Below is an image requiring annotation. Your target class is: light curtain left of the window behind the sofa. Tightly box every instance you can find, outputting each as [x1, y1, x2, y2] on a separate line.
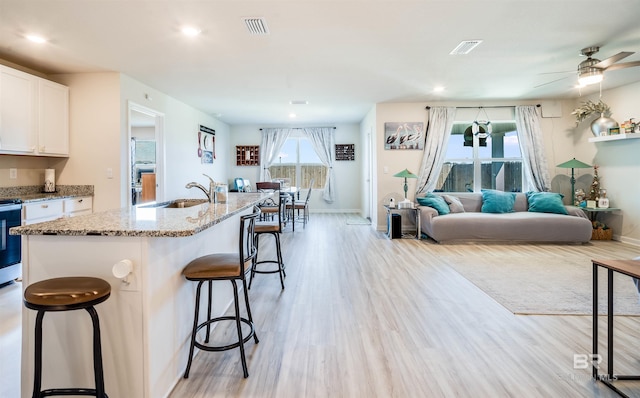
[416, 106, 456, 194]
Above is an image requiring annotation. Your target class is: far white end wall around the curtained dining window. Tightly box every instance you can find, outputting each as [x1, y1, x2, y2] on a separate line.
[228, 124, 363, 213]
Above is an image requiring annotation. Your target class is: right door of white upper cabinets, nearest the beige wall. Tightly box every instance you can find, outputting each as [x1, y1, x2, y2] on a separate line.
[38, 79, 69, 156]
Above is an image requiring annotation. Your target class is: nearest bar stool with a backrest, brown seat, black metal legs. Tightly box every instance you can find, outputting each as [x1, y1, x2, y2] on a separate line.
[182, 207, 260, 379]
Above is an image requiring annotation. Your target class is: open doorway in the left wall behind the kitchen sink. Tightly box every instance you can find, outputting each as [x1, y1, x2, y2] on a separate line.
[127, 102, 164, 206]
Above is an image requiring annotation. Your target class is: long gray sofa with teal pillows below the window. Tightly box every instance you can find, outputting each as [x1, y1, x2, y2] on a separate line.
[418, 192, 593, 243]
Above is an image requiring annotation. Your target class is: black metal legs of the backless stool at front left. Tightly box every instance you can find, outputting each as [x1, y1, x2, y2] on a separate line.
[33, 306, 108, 398]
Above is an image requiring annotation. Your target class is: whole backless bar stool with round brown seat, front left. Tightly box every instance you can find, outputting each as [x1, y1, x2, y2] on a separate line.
[24, 276, 111, 398]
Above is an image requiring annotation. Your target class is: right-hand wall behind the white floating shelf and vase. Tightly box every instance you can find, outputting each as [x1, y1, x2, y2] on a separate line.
[574, 83, 640, 245]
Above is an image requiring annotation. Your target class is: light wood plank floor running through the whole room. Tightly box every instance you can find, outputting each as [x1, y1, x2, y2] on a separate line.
[0, 214, 640, 398]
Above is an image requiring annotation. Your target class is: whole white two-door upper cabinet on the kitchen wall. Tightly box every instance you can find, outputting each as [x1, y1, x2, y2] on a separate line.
[0, 65, 69, 156]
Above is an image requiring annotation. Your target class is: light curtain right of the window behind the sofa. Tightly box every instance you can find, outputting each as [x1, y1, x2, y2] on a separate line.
[516, 105, 551, 192]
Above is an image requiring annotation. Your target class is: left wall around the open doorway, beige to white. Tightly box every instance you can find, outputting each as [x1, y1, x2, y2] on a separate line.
[55, 73, 229, 211]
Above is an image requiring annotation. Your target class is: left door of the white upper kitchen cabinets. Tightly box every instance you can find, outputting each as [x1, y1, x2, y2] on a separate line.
[0, 65, 38, 154]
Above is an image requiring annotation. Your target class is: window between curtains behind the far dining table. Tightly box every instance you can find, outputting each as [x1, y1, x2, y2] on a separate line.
[269, 137, 327, 189]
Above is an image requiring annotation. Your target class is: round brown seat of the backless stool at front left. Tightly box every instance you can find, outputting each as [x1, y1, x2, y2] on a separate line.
[24, 276, 111, 311]
